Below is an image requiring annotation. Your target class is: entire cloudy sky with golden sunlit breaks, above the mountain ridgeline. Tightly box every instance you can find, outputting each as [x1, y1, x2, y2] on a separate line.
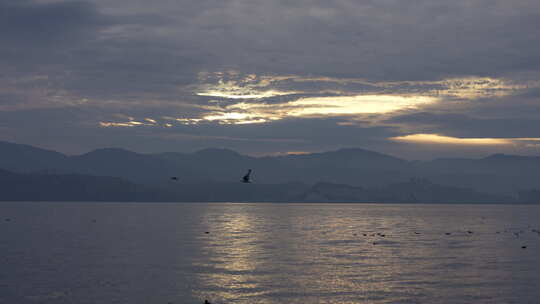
[0, 0, 540, 159]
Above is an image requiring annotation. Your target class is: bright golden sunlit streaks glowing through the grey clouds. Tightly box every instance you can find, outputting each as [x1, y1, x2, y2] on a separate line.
[96, 71, 540, 128]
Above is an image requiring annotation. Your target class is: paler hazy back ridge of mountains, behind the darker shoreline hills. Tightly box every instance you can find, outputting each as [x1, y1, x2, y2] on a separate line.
[0, 142, 540, 197]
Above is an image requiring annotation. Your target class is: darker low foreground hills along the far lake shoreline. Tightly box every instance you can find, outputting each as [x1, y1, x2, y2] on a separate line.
[0, 170, 516, 203]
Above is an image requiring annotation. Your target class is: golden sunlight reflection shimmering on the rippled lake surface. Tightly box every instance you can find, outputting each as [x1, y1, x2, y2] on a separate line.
[187, 203, 533, 304]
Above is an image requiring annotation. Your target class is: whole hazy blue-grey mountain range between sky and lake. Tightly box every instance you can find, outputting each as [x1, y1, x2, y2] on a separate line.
[0, 142, 540, 202]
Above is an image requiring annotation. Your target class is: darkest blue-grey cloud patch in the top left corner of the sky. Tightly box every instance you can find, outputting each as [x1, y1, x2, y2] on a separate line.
[0, 0, 110, 72]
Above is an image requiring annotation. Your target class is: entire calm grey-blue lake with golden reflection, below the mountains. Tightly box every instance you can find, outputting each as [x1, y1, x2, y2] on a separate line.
[0, 203, 540, 304]
